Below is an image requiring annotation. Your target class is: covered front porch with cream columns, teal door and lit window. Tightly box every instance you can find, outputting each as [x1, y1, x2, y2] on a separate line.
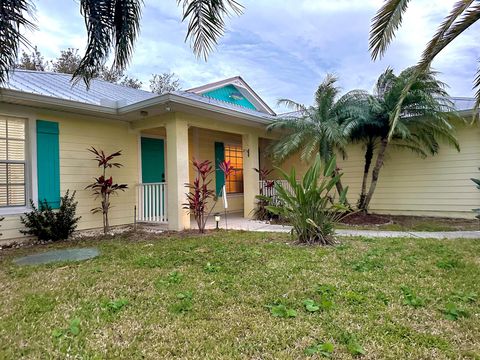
[133, 113, 274, 230]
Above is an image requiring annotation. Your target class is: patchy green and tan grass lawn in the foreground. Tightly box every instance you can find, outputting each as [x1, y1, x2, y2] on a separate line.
[0, 231, 480, 359]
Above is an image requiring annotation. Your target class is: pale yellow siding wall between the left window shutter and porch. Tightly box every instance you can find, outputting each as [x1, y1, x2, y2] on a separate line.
[0, 112, 138, 239]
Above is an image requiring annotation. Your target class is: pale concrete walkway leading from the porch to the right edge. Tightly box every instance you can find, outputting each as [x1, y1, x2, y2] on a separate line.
[202, 214, 480, 239]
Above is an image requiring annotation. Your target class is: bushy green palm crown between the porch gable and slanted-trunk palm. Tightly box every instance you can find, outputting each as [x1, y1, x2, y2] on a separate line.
[267, 74, 364, 205]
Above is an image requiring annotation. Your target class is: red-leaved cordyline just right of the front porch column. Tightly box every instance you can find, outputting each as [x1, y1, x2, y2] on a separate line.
[183, 160, 235, 234]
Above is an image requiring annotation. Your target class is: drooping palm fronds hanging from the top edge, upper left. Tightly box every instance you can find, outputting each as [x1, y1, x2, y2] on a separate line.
[0, 0, 243, 86]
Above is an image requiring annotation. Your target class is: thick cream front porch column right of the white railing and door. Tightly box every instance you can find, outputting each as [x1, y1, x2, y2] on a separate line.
[166, 118, 190, 231]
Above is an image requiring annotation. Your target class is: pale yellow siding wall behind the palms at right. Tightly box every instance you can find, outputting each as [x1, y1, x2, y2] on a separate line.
[261, 125, 480, 218]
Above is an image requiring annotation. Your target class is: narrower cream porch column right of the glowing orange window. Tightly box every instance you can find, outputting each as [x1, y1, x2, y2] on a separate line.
[242, 134, 259, 218]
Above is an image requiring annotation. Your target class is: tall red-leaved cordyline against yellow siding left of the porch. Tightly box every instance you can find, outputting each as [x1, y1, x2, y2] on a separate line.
[85, 146, 128, 234]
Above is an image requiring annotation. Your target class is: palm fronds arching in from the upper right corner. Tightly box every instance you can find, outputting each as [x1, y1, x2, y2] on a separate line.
[370, 0, 480, 137]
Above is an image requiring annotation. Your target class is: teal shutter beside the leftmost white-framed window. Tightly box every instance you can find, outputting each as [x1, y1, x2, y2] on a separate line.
[37, 120, 60, 209]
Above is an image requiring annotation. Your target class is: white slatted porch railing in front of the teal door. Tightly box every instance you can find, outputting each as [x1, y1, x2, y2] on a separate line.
[137, 183, 168, 223]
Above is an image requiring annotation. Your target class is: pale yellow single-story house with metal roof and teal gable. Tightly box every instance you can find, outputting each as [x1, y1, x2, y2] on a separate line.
[0, 70, 480, 239]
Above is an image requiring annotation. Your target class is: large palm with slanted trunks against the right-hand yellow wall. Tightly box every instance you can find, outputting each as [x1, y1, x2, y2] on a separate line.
[346, 67, 460, 212]
